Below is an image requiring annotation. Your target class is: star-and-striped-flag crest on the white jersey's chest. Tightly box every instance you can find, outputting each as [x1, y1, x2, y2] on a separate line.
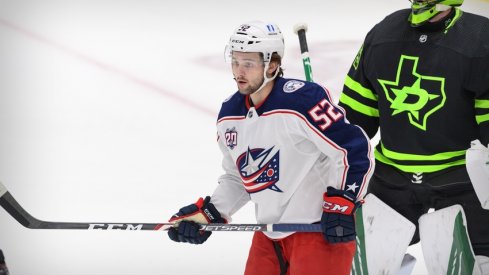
[236, 146, 282, 193]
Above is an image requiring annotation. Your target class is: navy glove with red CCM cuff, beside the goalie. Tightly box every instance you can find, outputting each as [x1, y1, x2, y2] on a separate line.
[321, 186, 362, 243]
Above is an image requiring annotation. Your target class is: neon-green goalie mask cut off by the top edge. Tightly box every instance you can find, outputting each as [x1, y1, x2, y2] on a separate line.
[409, 0, 464, 27]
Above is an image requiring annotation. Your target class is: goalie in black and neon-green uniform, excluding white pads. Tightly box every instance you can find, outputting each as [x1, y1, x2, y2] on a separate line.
[340, 0, 489, 274]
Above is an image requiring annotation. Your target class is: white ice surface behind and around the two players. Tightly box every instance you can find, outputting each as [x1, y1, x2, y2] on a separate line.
[0, 0, 489, 275]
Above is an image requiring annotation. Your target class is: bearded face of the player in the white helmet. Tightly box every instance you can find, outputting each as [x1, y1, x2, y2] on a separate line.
[231, 52, 265, 95]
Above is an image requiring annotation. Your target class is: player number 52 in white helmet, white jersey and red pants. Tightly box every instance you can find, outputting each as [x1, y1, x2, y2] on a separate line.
[168, 21, 373, 275]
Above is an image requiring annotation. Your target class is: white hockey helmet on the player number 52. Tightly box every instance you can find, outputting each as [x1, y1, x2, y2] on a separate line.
[225, 21, 284, 62]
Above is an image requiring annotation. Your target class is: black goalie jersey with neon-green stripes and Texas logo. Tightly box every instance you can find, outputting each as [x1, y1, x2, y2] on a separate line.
[340, 9, 489, 173]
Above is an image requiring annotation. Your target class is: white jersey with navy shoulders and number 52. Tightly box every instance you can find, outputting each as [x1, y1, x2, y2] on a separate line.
[211, 78, 374, 239]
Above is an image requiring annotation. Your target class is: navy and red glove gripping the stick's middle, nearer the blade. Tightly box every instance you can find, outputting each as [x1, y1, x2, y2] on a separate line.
[168, 196, 226, 244]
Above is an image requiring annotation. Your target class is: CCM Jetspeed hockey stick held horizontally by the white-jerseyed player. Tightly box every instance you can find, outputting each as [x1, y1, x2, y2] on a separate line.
[0, 182, 321, 232]
